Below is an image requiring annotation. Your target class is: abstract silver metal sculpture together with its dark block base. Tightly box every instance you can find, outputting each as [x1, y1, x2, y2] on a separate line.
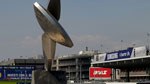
[32, 0, 73, 84]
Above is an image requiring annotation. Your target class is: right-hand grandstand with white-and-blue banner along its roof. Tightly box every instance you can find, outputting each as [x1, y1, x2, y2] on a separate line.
[91, 46, 150, 82]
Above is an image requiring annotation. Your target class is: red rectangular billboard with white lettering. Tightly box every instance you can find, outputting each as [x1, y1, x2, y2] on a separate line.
[89, 67, 111, 80]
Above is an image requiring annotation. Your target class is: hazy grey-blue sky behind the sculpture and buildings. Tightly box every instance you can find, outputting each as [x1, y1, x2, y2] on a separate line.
[0, 0, 150, 60]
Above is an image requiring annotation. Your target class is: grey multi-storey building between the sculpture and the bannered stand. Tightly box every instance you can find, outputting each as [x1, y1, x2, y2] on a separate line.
[52, 51, 97, 82]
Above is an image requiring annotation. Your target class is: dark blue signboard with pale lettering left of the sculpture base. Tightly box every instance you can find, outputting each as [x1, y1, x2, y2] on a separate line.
[0, 66, 44, 81]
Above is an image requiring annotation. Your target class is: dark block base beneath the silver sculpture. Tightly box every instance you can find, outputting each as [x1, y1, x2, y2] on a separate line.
[32, 70, 67, 84]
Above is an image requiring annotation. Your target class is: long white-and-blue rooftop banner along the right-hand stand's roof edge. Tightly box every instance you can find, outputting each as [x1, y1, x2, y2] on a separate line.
[92, 46, 147, 63]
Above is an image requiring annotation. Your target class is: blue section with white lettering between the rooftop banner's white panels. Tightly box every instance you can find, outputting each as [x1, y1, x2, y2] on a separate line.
[105, 48, 133, 61]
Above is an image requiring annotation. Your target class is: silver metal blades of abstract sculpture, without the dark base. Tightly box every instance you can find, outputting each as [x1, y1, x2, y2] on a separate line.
[34, 0, 73, 70]
